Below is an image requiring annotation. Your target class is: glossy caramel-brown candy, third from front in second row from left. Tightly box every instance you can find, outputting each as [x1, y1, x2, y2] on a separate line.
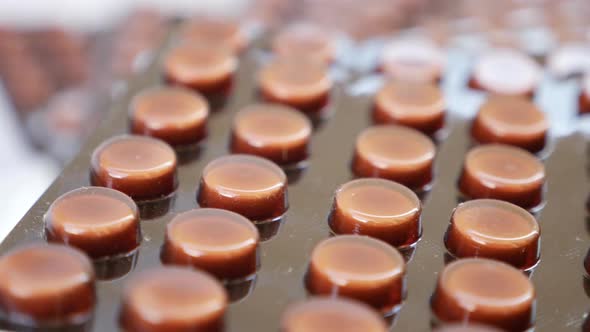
[197, 154, 288, 221]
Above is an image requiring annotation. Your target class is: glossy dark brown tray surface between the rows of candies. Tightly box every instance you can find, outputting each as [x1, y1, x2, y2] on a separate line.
[0, 24, 590, 332]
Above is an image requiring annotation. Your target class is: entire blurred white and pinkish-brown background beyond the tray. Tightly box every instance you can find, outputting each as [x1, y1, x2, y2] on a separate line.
[0, 0, 590, 239]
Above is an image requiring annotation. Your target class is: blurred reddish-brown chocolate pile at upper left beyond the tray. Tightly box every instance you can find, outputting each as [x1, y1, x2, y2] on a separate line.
[0, 10, 168, 162]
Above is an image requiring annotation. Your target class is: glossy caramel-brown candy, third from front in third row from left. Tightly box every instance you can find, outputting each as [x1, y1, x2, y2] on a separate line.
[329, 179, 422, 247]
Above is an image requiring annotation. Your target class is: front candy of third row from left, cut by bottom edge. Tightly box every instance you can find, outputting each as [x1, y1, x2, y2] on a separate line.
[280, 297, 388, 332]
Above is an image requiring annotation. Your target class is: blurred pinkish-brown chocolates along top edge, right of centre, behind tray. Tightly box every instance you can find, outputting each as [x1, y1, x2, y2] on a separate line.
[251, 0, 590, 53]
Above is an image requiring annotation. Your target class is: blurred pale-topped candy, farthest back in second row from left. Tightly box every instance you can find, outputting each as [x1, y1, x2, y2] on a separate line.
[272, 22, 336, 63]
